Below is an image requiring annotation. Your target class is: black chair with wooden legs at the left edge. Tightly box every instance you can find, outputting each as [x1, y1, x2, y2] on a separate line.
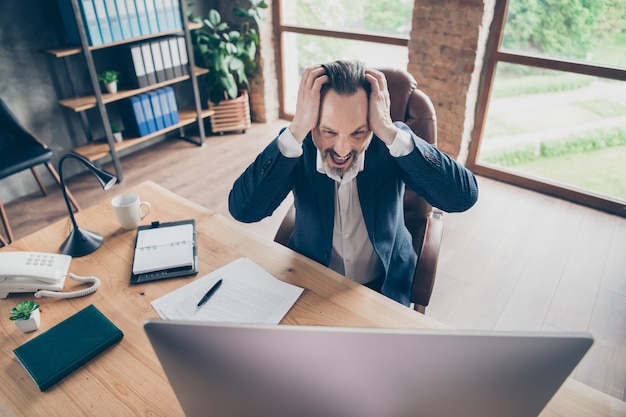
[0, 99, 80, 245]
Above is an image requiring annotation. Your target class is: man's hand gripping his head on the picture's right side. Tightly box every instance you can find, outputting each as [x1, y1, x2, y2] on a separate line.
[365, 68, 398, 146]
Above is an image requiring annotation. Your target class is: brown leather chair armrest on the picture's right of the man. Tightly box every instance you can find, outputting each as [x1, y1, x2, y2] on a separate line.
[411, 211, 443, 313]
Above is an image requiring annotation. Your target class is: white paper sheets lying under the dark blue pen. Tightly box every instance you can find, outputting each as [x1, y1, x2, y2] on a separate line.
[151, 258, 303, 324]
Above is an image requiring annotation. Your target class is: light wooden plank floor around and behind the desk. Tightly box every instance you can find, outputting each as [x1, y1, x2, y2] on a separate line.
[0, 121, 626, 400]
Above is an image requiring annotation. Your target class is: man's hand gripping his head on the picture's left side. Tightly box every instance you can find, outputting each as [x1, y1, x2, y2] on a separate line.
[289, 65, 328, 143]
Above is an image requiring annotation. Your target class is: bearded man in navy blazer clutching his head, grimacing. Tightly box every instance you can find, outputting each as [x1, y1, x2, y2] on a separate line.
[229, 61, 478, 305]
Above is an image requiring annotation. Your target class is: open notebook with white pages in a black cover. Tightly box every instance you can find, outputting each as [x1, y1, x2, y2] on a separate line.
[131, 219, 198, 284]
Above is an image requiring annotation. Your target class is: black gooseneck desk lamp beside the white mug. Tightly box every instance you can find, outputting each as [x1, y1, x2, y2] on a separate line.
[59, 153, 117, 257]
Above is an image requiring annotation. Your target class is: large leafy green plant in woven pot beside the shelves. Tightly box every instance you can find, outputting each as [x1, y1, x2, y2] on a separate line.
[189, 0, 267, 133]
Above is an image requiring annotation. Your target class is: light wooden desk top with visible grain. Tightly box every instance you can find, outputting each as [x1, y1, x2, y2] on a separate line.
[0, 182, 626, 417]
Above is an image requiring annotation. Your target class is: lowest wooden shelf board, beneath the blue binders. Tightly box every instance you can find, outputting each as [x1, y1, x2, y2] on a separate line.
[72, 109, 215, 162]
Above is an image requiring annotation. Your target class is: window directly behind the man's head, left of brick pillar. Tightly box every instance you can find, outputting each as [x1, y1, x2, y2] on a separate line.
[277, 0, 413, 117]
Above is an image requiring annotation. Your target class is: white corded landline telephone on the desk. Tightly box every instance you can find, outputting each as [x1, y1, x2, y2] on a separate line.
[0, 251, 100, 298]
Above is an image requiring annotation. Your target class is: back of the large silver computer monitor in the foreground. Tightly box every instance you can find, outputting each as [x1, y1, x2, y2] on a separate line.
[145, 320, 593, 417]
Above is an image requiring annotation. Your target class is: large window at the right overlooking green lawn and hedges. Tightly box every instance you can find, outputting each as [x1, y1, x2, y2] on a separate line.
[468, 0, 626, 215]
